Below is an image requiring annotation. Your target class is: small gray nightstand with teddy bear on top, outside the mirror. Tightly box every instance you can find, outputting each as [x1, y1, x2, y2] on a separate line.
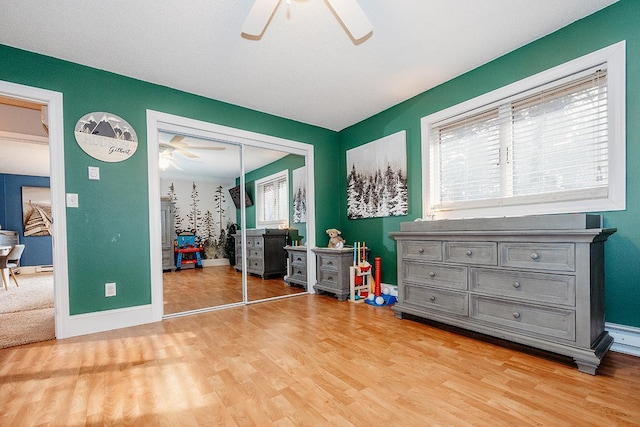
[312, 248, 353, 301]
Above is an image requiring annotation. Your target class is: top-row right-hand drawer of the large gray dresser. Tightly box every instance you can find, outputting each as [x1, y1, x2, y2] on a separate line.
[500, 243, 576, 271]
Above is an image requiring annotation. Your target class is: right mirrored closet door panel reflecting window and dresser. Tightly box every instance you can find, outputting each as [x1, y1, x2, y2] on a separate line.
[240, 146, 307, 301]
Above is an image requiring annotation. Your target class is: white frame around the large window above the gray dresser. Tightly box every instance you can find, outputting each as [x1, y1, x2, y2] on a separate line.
[421, 41, 626, 219]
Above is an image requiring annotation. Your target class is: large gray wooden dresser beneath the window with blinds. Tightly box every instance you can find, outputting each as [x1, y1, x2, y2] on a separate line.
[391, 214, 616, 374]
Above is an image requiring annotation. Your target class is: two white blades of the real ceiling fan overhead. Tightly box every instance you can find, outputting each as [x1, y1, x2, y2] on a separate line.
[242, 0, 373, 41]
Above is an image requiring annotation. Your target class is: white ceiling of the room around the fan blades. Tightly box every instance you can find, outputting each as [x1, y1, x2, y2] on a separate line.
[0, 0, 616, 130]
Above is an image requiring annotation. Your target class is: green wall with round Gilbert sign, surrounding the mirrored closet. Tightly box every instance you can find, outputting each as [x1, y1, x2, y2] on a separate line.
[0, 45, 339, 315]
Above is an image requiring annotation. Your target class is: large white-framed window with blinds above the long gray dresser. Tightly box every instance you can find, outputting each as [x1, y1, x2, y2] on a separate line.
[422, 42, 625, 218]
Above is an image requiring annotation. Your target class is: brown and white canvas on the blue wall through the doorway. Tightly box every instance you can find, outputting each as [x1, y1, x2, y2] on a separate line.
[22, 187, 53, 237]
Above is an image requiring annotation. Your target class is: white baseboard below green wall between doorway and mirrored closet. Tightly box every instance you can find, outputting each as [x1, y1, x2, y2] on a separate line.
[67, 304, 153, 337]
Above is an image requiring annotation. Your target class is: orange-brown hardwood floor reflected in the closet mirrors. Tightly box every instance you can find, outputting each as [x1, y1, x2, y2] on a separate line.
[162, 266, 305, 314]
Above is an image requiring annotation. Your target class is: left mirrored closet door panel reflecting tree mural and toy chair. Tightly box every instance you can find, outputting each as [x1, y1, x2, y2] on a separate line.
[159, 132, 243, 315]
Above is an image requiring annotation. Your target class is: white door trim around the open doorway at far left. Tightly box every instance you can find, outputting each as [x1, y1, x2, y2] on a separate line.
[0, 81, 71, 338]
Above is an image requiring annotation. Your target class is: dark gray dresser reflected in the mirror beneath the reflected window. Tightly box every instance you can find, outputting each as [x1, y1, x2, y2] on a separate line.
[233, 228, 287, 279]
